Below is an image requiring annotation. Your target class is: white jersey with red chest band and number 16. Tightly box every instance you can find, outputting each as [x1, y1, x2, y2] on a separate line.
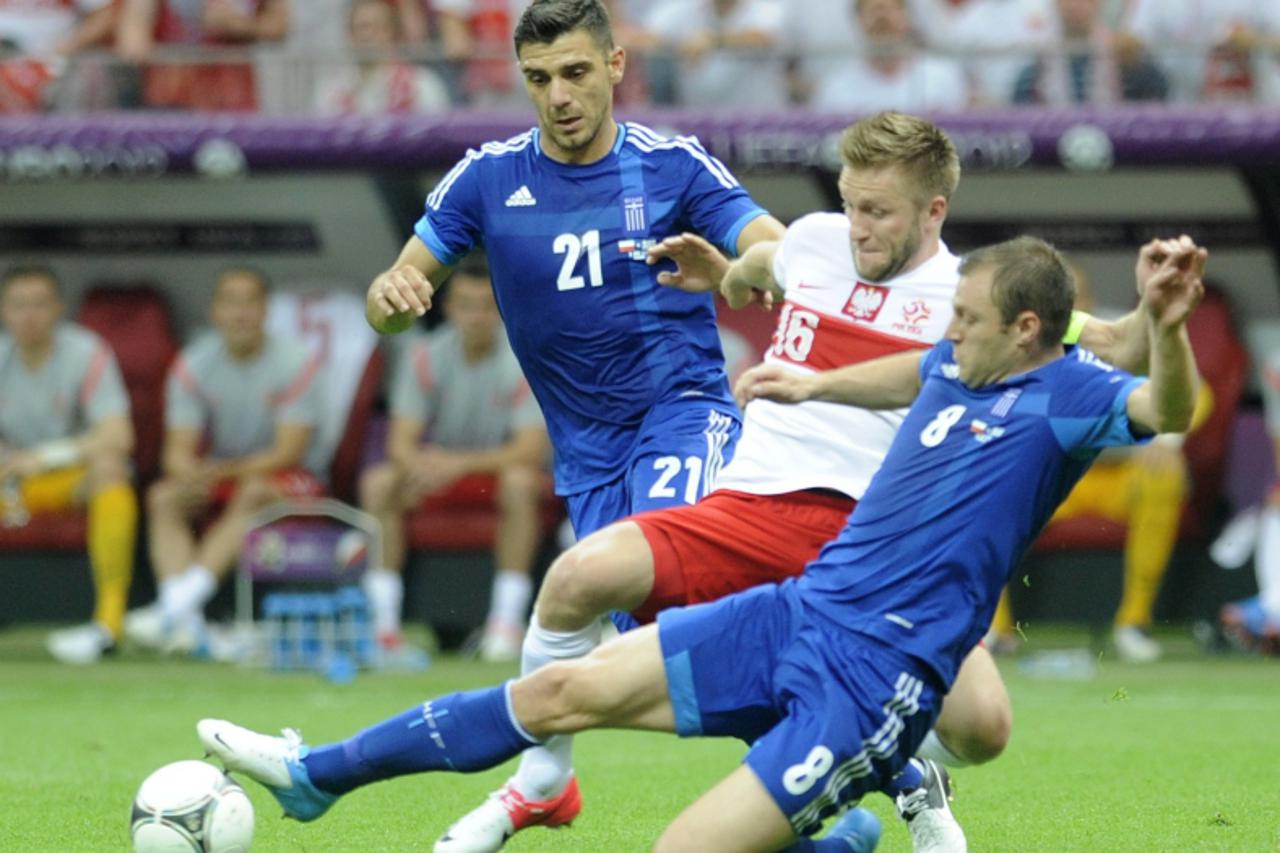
[716, 213, 960, 500]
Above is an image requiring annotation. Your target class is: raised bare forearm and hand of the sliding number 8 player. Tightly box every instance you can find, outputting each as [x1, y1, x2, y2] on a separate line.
[1126, 247, 1207, 433]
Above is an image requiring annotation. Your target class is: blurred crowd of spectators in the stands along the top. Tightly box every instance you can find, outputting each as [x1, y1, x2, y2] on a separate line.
[0, 0, 1280, 115]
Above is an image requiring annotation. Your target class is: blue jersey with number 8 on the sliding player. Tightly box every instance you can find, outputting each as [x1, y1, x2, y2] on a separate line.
[799, 341, 1143, 685]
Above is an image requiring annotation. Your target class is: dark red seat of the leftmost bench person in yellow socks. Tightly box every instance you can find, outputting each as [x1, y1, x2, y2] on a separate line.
[0, 283, 178, 552]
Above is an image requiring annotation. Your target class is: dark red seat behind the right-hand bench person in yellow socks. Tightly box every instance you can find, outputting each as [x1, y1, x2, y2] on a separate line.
[1034, 287, 1249, 552]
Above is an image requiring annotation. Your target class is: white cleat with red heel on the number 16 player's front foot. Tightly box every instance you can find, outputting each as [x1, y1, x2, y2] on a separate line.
[431, 777, 582, 853]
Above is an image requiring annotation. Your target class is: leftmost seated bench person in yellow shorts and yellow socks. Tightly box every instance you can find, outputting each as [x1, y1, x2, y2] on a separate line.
[0, 265, 138, 663]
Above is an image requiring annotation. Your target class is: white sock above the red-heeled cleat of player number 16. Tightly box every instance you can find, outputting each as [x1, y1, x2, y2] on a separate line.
[512, 616, 600, 799]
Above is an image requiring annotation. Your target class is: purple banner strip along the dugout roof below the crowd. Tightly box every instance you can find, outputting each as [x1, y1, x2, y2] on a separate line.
[0, 105, 1280, 181]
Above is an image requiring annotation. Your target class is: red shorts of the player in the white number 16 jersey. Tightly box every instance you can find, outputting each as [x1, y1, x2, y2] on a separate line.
[631, 489, 856, 622]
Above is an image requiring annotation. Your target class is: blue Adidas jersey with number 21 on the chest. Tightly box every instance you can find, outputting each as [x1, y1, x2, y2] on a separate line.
[415, 123, 764, 494]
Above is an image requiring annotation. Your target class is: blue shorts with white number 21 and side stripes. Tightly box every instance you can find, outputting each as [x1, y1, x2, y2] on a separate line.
[564, 397, 742, 631]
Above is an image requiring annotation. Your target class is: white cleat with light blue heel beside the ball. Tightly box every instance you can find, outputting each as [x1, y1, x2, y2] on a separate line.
[196, 720, 338, 821]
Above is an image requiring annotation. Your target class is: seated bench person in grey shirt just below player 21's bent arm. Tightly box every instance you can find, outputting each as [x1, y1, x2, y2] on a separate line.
[360, 259, 550, 661]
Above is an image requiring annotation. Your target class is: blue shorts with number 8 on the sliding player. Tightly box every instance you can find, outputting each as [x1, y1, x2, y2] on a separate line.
[658, 581, 942, 835]
